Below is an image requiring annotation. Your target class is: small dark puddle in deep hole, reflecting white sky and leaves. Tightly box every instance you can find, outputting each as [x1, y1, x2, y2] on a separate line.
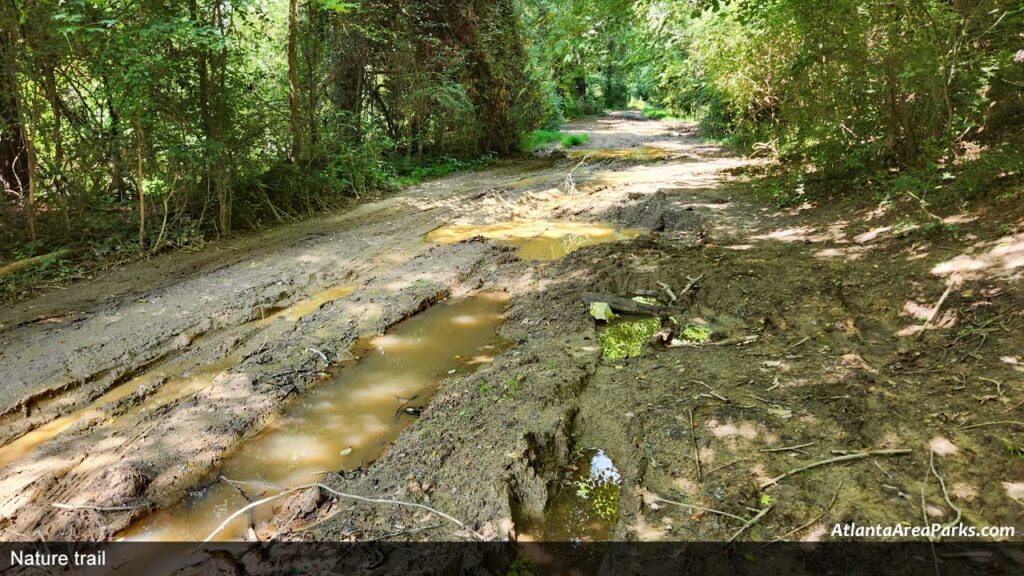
[516, 448, 623, 542]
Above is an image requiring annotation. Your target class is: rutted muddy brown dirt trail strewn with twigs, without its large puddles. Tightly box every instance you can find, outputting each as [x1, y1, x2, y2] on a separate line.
[0, 114, 1024, 540]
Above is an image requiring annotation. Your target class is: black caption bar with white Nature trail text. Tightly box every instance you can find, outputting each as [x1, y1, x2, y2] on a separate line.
[0, 542, 1024, 576]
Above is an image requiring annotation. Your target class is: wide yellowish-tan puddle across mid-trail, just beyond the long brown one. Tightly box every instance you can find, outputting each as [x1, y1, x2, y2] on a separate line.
[427, 220, 642, 260]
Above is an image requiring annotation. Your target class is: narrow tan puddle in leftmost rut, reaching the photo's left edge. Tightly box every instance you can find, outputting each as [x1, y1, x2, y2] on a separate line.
[0, 357, 239, 468]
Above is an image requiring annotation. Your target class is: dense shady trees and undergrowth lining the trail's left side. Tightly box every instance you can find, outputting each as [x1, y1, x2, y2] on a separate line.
[0, 0, 551, 289]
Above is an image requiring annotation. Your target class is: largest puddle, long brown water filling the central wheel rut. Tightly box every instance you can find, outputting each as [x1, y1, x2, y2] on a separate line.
[122, 293, 508, 542]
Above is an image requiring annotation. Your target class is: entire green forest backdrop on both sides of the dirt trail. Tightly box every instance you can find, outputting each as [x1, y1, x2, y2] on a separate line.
[0, 0, 1024, 290]
